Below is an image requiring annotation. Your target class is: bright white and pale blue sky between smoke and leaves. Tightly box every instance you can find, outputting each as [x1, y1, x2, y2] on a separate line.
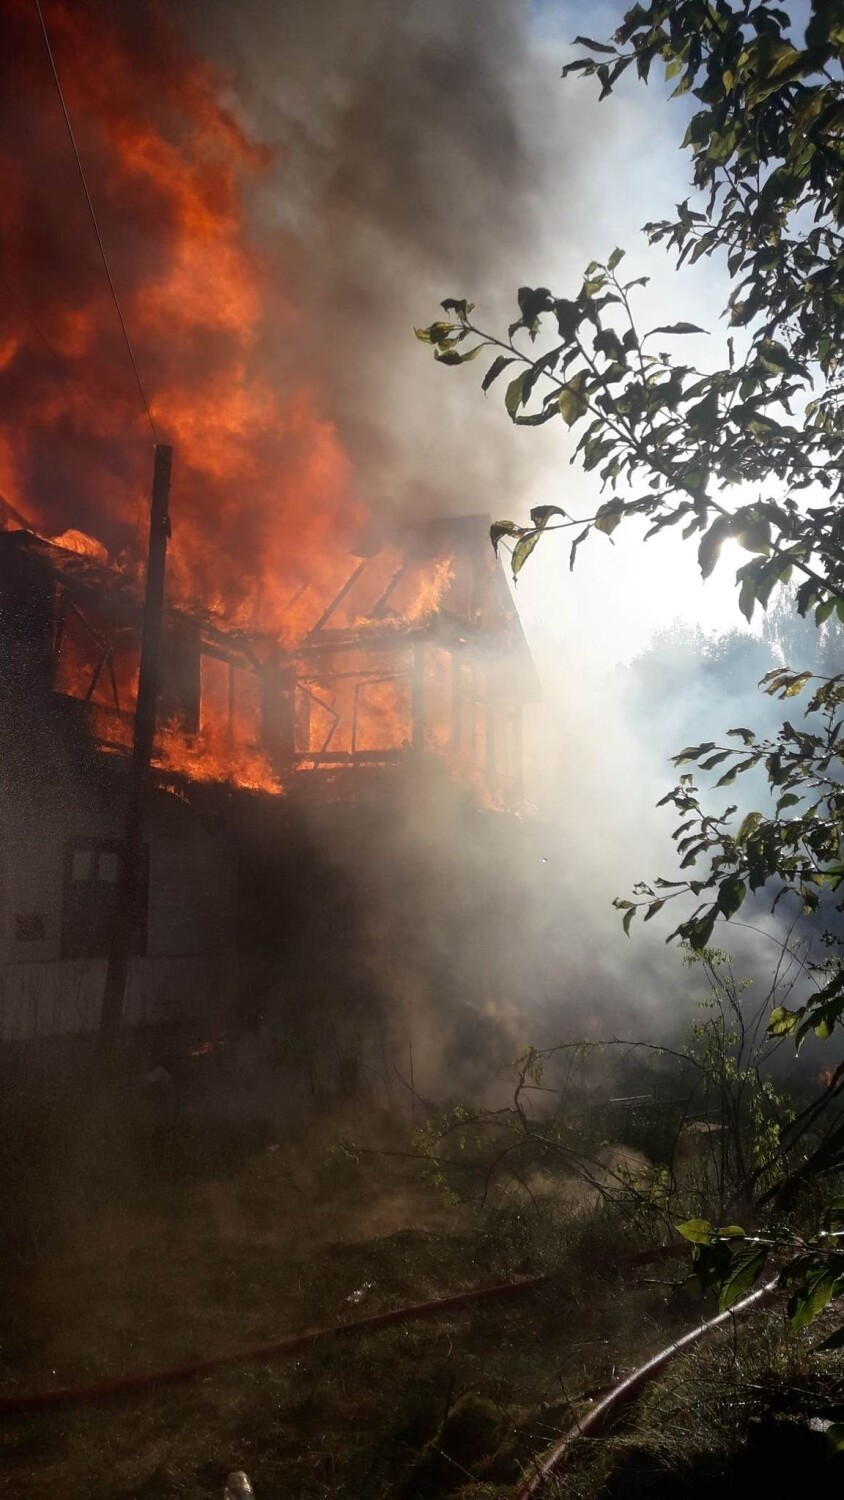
[511, 0, 758, 671]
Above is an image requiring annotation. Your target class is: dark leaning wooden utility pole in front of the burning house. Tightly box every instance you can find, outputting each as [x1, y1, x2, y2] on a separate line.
[99, 443, 172, 1053]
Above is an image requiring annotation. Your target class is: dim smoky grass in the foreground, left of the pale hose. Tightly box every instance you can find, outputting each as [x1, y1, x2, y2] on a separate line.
[0, 1056, 694, 1500]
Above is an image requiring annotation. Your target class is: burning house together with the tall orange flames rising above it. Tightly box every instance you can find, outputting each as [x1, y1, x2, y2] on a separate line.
[0, 0, 537, 1086]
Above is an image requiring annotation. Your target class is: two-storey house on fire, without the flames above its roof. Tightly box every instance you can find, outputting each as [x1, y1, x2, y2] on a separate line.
[0, 518, 537, 1068]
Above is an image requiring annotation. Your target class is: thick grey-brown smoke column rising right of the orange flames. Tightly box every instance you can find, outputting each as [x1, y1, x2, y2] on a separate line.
[183, 0, 600, 518]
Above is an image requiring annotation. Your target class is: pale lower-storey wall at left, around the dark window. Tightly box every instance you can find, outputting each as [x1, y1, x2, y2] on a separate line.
[0, 764, 241, 1041]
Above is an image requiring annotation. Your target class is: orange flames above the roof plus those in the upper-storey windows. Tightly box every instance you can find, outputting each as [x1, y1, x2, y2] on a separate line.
[0, 0, 515, 810]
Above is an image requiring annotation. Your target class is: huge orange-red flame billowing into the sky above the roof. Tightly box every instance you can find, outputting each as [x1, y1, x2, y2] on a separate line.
[0, 0, 364, 639]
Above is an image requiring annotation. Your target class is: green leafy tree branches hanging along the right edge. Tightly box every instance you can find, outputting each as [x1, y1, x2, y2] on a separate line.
[417, 0, 844, 1338]
